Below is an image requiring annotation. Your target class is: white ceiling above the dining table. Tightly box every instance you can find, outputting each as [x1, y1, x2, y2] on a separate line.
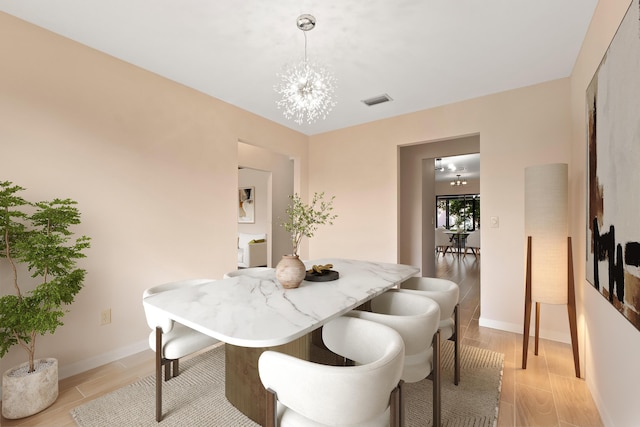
[0, 0, 597, 135]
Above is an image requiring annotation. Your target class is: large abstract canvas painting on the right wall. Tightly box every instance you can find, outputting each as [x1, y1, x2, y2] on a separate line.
[586, 0, 640, 330]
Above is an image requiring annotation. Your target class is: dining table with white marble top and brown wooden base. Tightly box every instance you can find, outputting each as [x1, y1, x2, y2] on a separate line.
[143, 258, 420, 425]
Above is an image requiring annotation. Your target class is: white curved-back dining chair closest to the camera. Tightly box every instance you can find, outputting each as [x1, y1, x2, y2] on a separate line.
[258, 317, 404, 427]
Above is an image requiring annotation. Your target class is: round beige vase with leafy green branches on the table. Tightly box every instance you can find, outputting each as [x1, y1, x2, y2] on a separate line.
[276, 192, 338, 289]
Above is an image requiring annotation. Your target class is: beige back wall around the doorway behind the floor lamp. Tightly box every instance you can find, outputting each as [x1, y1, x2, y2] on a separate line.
[309, 79, 571, 341]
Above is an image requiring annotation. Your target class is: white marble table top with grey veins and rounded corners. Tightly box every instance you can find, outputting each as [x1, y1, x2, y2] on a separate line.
[143, 259, 420, 347]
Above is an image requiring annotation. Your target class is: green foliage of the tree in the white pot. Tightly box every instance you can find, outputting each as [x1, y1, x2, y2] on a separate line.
[0, 181, 90, 372]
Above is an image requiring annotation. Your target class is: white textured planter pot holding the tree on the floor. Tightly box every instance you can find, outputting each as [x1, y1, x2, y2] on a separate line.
[2, 359, 58, 419]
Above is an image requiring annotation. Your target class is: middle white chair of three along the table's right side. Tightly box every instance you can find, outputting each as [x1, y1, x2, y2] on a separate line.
[348, 289, 442, 426]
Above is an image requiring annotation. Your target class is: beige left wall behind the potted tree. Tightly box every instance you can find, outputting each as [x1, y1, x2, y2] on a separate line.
[0, 13, 307, 376]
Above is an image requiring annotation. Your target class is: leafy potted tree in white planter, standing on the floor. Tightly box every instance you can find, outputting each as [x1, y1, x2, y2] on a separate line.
[0, 181, 90, 419]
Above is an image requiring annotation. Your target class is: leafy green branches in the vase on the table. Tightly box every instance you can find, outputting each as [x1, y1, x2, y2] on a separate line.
[281, 192, 338, 255]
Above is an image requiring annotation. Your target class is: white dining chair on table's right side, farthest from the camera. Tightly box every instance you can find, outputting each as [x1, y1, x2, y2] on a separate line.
[399, 277, 460, 385]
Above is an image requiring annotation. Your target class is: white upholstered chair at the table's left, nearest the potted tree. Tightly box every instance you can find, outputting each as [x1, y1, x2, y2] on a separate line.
[142, 279, 219, 422]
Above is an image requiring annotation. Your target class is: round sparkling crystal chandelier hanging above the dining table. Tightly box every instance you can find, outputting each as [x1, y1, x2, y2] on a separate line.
[274, 14, 336, 125]
